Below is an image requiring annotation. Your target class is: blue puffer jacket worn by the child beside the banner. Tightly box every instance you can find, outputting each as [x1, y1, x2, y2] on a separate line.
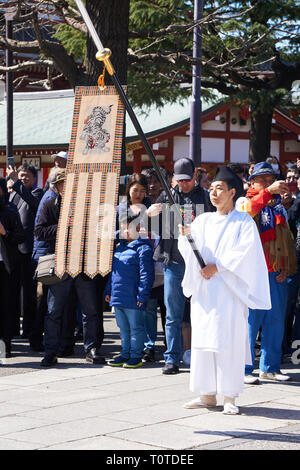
[105, 238, 154, 310]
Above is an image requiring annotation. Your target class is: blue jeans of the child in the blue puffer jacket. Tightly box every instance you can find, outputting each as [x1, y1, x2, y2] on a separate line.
[114, 306, 145, 359]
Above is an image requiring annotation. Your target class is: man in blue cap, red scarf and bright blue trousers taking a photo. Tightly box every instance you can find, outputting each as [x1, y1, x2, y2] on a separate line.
[237, 162, 297, 384]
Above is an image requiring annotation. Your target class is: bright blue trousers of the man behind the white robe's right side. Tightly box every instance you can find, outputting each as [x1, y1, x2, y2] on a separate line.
[246, 272, 288, 375]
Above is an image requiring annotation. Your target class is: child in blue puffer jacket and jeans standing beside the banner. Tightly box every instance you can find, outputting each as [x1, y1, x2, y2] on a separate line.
[105, 216, 154, 368]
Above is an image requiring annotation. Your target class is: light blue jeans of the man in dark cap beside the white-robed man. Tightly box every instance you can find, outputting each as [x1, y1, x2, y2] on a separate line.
[164, 263, 185, 365]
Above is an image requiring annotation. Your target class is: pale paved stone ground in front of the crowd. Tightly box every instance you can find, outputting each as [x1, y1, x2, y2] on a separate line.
[0, 313, 300, 452]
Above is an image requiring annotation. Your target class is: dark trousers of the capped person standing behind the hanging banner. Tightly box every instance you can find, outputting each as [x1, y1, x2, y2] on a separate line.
[45, 274, 104, 354]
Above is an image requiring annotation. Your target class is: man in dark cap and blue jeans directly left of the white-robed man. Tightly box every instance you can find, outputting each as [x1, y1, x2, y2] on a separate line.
[147, 158, 214, 375]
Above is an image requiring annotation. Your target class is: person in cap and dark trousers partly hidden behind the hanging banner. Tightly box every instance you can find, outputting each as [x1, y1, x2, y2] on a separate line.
[35, 168, 105, 367]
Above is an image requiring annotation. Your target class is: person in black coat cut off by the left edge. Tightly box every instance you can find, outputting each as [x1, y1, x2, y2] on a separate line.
[0, 178, 25, 357]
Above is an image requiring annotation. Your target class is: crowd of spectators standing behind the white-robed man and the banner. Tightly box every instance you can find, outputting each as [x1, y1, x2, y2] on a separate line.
[0, 152, 300, 406]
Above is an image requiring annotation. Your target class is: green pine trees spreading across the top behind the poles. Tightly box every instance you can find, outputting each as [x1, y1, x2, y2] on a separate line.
[0, 0, 300, 161]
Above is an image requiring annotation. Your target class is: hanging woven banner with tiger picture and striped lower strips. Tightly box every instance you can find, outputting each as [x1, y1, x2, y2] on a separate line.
[55, 86, 124, 278]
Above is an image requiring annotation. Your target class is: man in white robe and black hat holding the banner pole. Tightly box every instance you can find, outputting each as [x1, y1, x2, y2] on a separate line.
[178, 167, 271, 414]
